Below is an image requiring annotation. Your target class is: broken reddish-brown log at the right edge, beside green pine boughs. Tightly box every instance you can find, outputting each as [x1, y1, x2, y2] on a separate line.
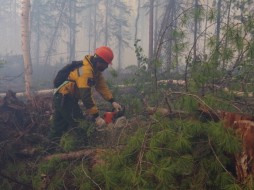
[198, 105, 254, 182]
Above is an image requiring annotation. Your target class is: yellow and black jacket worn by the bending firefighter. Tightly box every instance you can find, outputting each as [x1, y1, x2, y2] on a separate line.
[58, 55, 114, 115]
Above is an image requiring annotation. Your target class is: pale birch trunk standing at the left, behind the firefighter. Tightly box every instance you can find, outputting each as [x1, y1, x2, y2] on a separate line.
[21, 0, 32, 99]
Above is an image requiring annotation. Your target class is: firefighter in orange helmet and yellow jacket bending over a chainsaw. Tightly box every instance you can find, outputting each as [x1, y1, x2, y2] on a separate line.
[50, 46, 121, 138]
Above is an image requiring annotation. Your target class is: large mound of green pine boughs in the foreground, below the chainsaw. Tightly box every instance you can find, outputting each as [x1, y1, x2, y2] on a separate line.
[89, 118, 241, 189]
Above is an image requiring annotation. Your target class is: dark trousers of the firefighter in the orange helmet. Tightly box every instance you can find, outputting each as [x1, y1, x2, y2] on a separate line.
[49, 93, 84, 138]
